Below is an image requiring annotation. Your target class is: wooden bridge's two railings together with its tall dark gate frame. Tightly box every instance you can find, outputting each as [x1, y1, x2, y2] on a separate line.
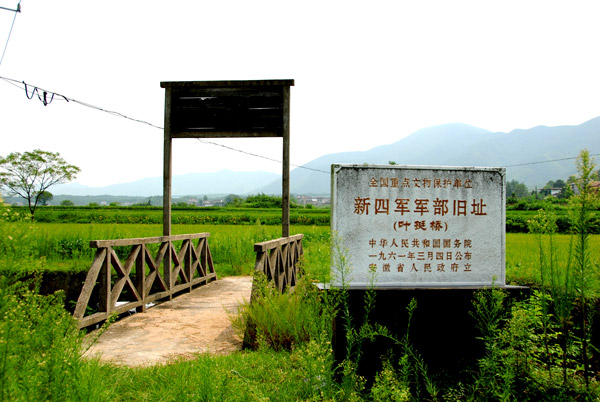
[74, 80, 303, 364]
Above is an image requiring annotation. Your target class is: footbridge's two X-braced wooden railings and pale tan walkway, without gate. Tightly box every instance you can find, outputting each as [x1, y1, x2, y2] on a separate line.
[74, 233, 304, 364]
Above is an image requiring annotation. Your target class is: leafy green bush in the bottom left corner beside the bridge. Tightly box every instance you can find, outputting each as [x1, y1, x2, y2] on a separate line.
[0, 276, 82, 401]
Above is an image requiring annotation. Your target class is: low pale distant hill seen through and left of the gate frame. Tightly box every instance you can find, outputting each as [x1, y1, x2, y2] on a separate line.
[50, 170, 281, 197]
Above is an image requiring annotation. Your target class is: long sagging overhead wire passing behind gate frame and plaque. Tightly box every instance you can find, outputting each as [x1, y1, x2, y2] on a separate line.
[0, 76, 600, 174]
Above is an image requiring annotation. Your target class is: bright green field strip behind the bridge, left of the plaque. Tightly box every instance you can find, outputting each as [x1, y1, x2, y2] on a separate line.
[0, 222, 329, 275]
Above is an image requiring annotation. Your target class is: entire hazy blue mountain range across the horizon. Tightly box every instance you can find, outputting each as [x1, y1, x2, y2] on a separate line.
[51, 117, 600, 196]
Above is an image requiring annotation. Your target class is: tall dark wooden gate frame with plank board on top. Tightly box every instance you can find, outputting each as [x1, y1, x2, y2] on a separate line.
[160, 80, 294, 237]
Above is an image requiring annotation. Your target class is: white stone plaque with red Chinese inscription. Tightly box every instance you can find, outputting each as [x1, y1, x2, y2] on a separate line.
[331, 165, 505, 287]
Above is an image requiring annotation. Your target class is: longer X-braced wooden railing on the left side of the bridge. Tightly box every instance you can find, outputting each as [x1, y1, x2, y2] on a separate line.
[73, 233, 217, 328]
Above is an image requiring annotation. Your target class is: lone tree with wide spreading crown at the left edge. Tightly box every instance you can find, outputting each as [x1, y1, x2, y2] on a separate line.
[0, 149, 80, 217]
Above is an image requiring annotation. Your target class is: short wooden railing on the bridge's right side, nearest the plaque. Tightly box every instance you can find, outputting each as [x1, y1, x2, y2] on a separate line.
[254, 234, 304, 292]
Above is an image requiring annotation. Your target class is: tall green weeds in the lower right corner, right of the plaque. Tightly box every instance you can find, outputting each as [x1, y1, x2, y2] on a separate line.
[470, 150, 599, 401]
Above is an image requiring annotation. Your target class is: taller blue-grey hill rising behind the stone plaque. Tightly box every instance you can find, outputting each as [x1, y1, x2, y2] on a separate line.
[258, 117, 600, 194]
